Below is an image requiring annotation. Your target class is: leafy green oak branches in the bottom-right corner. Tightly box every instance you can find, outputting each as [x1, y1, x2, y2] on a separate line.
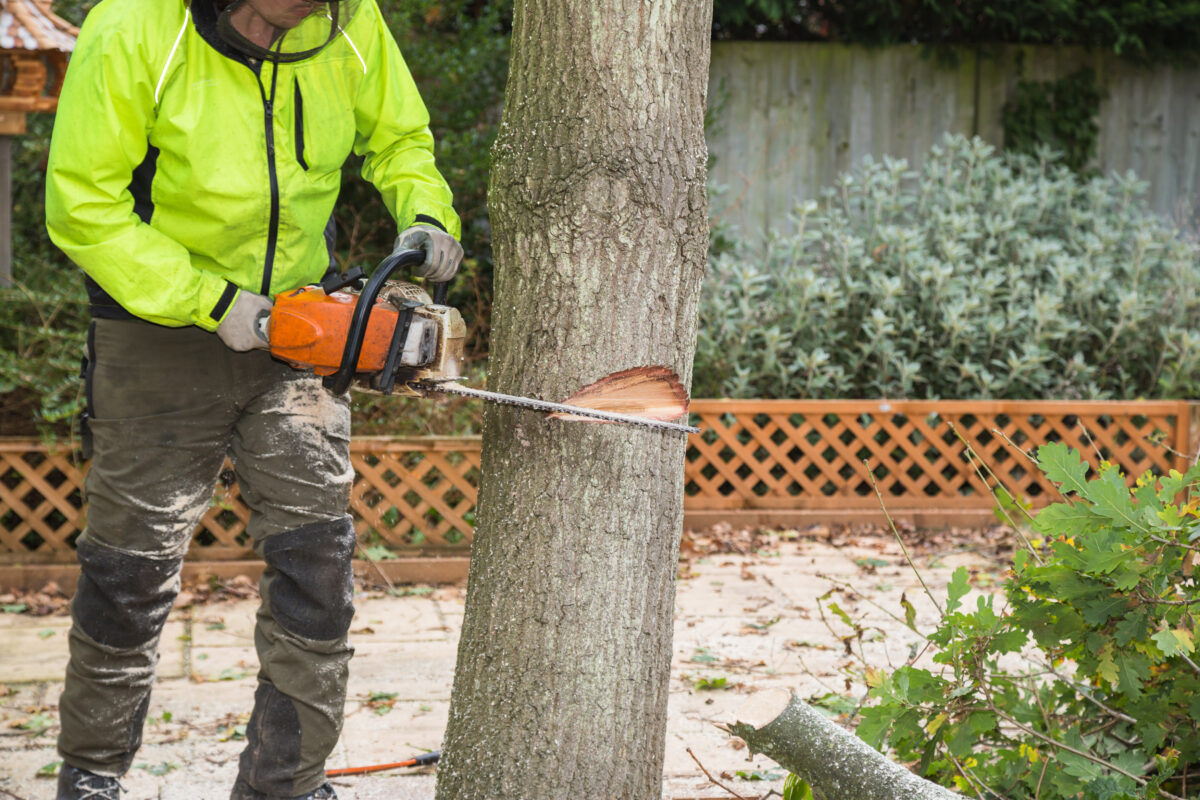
[858, 444, 1200, 800]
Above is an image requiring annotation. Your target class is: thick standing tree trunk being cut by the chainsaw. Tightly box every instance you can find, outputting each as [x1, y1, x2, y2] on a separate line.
[437, 0, 712, 800]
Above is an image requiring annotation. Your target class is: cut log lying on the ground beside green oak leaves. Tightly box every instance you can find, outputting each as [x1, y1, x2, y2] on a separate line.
[726, 692, 962, 800]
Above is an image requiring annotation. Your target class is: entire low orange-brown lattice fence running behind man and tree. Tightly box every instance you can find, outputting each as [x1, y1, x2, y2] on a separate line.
[0, 399, 1200, 565]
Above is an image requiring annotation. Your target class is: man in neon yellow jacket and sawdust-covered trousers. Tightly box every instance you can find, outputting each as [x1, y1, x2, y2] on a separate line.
[46, 0, 462, 799]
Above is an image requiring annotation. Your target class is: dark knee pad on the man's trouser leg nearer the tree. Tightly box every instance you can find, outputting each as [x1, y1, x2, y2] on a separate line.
[263, 517, 354, 640]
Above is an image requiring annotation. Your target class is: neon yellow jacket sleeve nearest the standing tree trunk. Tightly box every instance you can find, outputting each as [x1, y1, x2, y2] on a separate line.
[354, 0, 462, 239]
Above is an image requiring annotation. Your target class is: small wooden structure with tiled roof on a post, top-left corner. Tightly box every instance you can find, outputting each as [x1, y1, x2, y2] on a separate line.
[0, 0, 79, 285]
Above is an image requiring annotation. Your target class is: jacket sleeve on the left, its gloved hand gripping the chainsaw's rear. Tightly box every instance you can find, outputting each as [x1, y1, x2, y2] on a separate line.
[46, 8, 238, 331]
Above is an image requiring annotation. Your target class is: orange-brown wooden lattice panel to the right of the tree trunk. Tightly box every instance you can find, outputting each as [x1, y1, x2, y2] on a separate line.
[686, 401, 1189, 509]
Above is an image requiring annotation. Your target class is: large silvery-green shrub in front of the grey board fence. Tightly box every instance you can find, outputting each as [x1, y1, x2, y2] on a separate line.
[695, 137, 1200, 398]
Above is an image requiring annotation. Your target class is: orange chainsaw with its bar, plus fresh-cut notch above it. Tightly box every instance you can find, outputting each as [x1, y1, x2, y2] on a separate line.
[263, 249, 700, 433]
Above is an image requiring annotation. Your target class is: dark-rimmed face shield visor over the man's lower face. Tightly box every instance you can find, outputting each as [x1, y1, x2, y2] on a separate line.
[217, 0, 359, 64]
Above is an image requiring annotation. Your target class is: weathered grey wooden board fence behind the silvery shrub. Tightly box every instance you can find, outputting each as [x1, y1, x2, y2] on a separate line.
[709, 42, 1200, 239]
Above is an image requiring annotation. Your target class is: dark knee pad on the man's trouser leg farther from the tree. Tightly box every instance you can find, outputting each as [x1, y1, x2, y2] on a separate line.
[72, 540, 184, 650]
